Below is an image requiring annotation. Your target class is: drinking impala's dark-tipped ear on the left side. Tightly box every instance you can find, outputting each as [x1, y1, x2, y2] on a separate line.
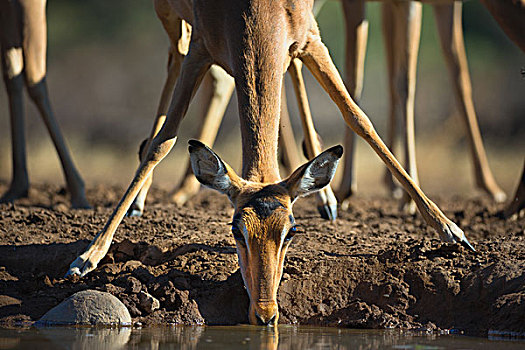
[188, 140, 242, 199]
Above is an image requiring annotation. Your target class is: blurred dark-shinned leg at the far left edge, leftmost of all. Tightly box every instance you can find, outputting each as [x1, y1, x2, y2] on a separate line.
[0, 1, 29, 203]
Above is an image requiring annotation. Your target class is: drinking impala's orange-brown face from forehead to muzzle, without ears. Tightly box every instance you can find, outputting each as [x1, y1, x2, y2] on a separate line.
[232, 184, 294, 324]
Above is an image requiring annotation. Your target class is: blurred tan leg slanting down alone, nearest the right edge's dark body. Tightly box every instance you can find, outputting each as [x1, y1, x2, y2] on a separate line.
[434, 2, 506, 202]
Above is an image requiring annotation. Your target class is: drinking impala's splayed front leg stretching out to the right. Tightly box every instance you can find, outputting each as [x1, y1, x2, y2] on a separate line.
[301, 37, 474, 250]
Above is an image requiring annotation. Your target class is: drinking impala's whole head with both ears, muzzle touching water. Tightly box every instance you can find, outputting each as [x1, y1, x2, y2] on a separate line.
[189, 140, 343, 325]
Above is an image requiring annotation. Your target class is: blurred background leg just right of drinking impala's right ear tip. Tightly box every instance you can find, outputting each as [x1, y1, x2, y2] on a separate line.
[337, 0, 368, 210]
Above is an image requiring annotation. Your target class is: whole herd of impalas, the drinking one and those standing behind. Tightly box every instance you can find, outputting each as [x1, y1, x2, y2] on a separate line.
[0, 0, 525, 324]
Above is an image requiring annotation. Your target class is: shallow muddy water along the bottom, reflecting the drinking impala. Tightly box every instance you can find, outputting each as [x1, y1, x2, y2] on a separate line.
[0, 325, 525, 350]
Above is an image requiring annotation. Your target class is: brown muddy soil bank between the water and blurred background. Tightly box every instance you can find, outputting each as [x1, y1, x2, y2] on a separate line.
[0, 183, 525, 334]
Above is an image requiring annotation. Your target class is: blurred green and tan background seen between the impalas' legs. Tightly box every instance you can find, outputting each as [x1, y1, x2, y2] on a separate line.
[0, 0, 525, 198]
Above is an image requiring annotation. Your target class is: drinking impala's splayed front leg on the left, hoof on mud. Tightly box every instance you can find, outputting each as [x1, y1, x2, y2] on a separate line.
[67, 39, 211, 276]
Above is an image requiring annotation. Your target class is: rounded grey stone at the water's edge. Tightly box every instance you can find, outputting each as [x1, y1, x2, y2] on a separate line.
[35, 290, 131, 326]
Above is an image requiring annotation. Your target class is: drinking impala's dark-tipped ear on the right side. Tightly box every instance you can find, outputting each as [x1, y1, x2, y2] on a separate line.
[283, 146, 343, 201]
